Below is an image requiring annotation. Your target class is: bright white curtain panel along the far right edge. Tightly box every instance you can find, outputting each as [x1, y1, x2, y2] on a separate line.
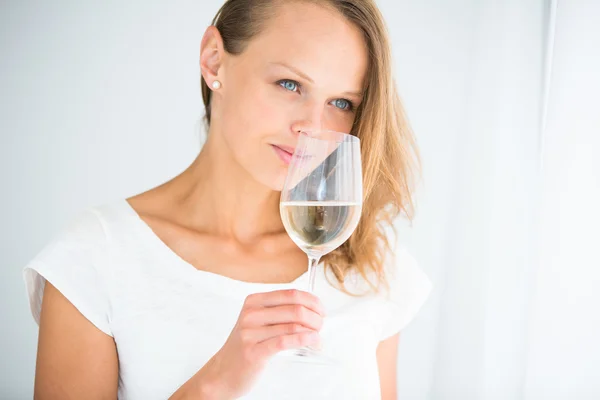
[523, 0, 600, 400]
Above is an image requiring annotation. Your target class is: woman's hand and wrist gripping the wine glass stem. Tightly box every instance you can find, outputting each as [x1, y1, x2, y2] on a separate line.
[197, 289, 324, 399]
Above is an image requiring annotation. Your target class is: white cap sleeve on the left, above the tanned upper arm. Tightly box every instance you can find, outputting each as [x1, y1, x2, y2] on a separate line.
[23, 208, 112, 336]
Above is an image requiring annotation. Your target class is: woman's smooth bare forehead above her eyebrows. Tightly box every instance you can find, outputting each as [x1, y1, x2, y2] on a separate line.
[244, 1, 368, 90]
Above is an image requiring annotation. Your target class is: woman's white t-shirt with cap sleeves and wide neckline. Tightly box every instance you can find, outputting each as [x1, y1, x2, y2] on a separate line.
[24, 200, 431, 400]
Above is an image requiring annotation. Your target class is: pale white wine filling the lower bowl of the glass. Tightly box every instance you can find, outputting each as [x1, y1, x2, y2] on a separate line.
[280, 201, 361, 256]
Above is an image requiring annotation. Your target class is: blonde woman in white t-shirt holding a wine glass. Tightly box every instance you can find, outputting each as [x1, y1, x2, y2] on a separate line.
[25, 0, 430, 400]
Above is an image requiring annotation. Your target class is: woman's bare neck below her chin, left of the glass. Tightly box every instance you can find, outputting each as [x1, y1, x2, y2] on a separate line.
[169, 134, 284, 243]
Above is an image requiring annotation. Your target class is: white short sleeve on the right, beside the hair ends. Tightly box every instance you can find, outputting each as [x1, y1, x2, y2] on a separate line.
[380, 248, 432, 340]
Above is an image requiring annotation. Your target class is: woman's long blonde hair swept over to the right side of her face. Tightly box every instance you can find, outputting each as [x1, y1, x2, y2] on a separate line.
[201, 0, 420, 291]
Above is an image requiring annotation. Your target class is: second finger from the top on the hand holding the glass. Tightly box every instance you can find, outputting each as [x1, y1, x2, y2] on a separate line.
[242, 304, 323, 331]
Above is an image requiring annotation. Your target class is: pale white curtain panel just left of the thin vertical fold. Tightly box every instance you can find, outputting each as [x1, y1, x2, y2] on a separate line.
[432, 0, 544, 400]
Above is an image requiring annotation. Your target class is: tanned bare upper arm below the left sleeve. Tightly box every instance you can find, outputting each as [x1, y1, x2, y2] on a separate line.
[34, 282, 119, 400]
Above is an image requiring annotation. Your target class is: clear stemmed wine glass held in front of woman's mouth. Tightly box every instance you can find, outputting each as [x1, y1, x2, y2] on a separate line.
[279, 131, 363, 362]
